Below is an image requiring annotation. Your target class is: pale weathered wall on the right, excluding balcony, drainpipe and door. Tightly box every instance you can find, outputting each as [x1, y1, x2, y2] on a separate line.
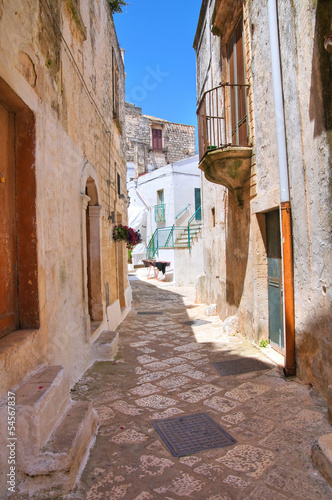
[195, 0, 332, 393]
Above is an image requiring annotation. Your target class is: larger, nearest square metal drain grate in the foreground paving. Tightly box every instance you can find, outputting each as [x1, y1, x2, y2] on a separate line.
[151, 413, 236, 457]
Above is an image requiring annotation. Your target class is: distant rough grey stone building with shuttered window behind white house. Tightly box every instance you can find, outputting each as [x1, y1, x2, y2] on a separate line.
[126, 103, 195, 178]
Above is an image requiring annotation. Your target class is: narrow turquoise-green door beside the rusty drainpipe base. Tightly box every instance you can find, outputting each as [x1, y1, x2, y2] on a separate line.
[266, 210, 284, 349]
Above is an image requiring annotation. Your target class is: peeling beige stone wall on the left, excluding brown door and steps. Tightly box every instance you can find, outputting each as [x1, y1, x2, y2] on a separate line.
[0, 0, 129, 395]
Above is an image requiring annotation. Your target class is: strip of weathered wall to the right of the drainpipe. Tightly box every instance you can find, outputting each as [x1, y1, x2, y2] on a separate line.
[279, 0, 332, 394]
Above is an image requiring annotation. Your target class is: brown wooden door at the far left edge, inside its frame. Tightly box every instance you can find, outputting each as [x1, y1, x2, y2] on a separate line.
[0, 105, 18, 337]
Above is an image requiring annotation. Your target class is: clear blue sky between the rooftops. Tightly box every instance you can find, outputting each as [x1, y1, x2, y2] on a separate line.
[114, 0, 201, 135]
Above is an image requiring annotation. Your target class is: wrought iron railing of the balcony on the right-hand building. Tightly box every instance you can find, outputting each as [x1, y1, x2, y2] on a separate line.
[197, 83, 249, 160]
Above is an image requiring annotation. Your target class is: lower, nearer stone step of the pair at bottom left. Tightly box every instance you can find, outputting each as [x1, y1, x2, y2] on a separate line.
[20, 401, 98, 498]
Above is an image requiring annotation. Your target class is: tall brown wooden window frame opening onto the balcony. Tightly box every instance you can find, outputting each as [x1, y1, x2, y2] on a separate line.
[227, 18, 248, 146]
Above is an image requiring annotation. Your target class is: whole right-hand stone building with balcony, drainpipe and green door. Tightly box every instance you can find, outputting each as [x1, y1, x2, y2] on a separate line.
[194, 0, 332, 395]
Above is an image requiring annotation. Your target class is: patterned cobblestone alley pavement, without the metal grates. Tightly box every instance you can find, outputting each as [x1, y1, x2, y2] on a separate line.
[66, 273, 332, 500]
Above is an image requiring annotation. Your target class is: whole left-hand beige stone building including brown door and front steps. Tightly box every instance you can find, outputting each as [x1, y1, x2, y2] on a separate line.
[0, 0, 130, 498]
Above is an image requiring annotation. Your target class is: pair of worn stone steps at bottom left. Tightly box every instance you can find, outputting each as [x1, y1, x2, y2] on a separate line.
[0, 366, 98, 499]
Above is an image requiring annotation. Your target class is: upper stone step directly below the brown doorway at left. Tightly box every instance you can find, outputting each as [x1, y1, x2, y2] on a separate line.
[14, 366, 70, 455]
